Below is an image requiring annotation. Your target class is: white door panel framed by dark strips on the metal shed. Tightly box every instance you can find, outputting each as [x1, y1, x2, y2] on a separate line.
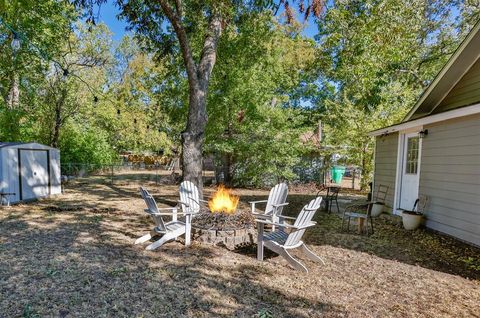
[19, 149, 49, 200]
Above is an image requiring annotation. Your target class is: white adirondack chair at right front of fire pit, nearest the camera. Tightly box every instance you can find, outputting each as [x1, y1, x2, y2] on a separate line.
[257, 197, 325, 273]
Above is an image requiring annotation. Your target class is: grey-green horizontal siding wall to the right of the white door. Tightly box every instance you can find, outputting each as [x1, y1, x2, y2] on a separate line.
[419, 116, 480, 246]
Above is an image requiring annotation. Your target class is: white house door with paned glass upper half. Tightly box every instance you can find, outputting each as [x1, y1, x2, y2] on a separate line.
[400, 133, 421, 210]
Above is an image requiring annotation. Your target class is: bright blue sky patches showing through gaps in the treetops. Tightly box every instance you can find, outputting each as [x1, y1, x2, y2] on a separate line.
[94, 1, 317, 42]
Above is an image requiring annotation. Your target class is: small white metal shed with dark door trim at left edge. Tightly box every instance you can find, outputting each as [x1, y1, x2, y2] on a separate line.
[0, 142, 62, 203]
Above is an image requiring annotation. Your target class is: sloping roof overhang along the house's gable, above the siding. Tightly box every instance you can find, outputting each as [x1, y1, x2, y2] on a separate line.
[402, 21, 480, 122]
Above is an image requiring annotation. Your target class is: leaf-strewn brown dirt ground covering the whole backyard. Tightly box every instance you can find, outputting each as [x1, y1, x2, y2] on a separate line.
[0, 177, 480, 317]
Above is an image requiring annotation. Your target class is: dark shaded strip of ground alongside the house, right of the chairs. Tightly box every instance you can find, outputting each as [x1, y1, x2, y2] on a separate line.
[242, 194, 480, 279]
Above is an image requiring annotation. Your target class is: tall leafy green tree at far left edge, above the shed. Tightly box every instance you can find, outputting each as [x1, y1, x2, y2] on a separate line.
[0, 0, 77, 140]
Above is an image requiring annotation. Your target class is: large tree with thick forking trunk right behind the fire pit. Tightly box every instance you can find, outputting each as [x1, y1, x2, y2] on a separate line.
[73, 0, 321, 194]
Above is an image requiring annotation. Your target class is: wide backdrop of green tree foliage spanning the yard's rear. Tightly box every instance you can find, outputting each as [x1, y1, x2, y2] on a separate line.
[0, 0, 479, 185]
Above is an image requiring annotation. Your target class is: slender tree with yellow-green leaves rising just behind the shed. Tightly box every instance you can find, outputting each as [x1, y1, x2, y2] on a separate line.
[39, 24, 112, 148]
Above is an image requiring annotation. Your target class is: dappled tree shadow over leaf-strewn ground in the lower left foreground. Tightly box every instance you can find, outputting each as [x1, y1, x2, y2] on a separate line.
[0, 210, 346, 317]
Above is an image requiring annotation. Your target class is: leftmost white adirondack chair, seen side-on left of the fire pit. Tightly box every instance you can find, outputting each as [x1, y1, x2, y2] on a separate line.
[135, 187, 192, 250]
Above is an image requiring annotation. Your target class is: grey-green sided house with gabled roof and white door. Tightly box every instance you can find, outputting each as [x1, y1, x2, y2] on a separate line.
[370, 23, 480, 246]
